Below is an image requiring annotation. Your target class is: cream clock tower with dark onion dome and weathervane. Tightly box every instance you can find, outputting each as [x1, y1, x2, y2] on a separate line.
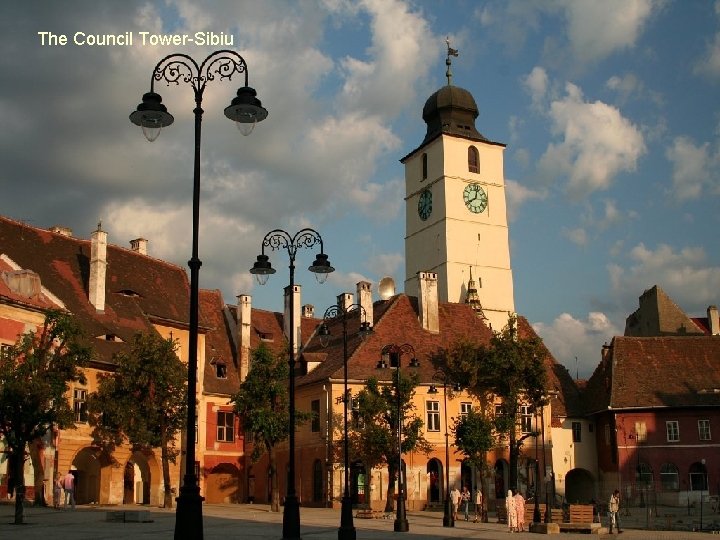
[400, 45, 515, 331]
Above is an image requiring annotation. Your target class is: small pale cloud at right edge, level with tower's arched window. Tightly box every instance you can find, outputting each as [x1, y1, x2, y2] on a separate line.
[665, 137, 720, 201]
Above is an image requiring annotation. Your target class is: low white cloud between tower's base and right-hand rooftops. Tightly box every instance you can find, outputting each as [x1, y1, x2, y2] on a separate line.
[532, 312, 624, 378]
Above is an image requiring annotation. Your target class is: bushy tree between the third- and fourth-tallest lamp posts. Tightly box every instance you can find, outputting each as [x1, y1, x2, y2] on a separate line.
[349, 370, 432, 512]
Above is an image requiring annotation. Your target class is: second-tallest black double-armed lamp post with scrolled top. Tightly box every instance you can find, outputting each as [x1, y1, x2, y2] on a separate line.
[250, 228, 335, 540]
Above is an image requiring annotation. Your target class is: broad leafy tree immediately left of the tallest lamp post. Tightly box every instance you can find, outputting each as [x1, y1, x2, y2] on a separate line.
[88, 333, 187, 508]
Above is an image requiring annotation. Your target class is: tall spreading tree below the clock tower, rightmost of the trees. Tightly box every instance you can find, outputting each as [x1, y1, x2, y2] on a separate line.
[441, 317, 547, 491]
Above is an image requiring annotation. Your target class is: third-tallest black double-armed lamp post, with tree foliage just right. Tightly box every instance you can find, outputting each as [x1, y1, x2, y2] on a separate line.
[318, 304, 372, 540]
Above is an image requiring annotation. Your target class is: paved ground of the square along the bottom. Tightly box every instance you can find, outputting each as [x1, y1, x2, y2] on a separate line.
[0, 503, 720, 540]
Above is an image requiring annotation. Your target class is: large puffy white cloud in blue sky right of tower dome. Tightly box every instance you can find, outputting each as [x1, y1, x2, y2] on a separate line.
[539, 83, 646, 200]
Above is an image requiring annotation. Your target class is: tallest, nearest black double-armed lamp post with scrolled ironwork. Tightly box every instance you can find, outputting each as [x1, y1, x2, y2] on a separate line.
[130, 50, 268, 539]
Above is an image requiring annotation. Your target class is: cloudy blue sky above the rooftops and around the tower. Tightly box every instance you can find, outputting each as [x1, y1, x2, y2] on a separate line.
[0, 0, 720, 377]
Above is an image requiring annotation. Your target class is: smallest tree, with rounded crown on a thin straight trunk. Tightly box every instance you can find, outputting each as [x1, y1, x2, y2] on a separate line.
[452, 409, 495, 522]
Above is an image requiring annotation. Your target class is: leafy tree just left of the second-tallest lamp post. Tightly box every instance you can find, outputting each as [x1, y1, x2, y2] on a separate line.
[231, 343, 310, 512]
